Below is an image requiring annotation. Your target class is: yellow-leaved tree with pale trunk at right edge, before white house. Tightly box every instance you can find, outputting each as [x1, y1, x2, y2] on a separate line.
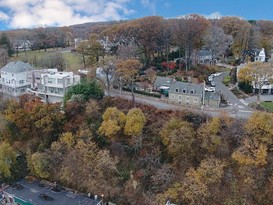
[238, 62, 273, 105]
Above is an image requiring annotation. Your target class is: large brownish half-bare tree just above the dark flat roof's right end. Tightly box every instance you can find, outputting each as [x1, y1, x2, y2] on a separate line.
[59, 140, 118, 197]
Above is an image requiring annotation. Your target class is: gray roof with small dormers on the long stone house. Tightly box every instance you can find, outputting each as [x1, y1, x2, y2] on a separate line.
[169, 81, 203, 95]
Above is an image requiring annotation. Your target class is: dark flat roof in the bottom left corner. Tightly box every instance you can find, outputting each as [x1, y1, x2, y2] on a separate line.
[4, 179, 99, 205]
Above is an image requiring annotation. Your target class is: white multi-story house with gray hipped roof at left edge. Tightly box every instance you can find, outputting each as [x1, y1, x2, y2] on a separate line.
[0, 61, 33, 97]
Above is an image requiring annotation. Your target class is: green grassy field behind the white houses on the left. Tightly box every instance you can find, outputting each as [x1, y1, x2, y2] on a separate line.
[13, 48, 82, 72]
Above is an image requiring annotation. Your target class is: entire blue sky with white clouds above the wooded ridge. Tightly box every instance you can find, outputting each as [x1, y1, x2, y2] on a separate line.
[0, 0, 273, 30]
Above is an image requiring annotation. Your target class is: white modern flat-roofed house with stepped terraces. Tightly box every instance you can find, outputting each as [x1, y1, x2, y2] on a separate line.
[28, 69, 80, 103]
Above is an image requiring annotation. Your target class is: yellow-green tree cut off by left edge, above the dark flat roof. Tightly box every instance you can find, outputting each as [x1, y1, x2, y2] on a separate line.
[0, 142, 16, 179]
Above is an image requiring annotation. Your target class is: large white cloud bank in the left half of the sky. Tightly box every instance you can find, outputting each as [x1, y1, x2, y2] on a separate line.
[0, 0, 134, 28]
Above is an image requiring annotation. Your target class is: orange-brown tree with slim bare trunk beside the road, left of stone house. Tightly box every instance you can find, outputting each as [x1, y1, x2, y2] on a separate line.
[117, 59, 141, 107]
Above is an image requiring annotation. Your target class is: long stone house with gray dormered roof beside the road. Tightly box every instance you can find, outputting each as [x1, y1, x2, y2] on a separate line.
[169, 81, 204, 108]
